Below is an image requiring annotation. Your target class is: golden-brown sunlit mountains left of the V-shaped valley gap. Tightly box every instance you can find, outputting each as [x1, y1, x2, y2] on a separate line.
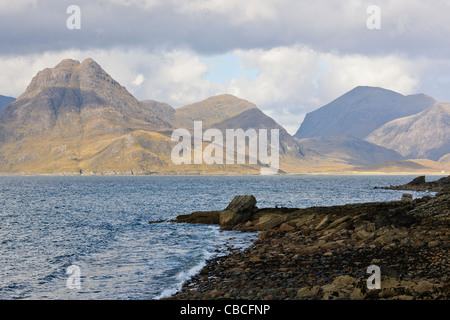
[0, 58, 301, 174]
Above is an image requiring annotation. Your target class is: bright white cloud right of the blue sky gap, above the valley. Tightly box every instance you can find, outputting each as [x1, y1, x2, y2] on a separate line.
[229, 46, 420, 134]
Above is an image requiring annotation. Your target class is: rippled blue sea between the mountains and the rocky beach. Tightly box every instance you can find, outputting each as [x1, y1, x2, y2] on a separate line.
[0, 175, 439, 300]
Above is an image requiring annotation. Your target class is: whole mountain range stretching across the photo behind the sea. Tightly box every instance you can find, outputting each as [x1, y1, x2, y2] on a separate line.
[0, 58, 450, 174]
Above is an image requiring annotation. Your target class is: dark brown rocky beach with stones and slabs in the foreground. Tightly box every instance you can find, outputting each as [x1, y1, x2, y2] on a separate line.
[163, 178, 450, 300]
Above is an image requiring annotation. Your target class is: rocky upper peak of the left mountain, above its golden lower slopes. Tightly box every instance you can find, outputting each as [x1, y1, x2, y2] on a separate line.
[0, 58, 166, 139]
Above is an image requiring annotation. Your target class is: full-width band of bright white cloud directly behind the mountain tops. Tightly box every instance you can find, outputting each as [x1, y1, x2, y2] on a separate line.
[0, 46, 440, 134]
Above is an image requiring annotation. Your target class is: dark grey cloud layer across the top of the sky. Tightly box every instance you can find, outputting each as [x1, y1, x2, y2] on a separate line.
[0, 0, 450, 58]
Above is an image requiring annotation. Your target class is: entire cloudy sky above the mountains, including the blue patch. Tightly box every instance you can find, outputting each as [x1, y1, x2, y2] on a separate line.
[0, 0, 450, 134]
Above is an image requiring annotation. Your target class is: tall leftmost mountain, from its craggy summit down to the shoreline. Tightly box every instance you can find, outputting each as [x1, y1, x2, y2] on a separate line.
[0, 58, 173, 173]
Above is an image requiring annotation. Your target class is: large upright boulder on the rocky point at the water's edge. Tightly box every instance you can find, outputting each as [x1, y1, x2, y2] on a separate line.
[219, 195, 257, 229]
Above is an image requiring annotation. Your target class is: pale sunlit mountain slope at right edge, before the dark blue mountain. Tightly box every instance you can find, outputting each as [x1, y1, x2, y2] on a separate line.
[366, 103, 450, 161]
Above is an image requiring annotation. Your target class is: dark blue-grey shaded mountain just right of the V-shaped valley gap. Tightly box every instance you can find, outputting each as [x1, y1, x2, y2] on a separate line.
[294, 87, 436, 139]
